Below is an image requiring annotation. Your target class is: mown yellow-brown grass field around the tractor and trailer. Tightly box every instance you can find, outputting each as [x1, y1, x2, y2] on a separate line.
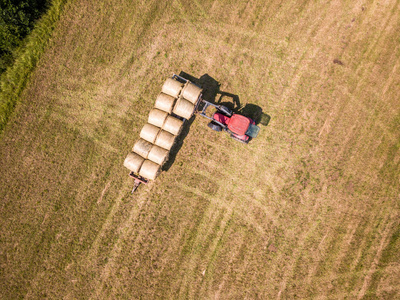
[0, 0, 400, 299]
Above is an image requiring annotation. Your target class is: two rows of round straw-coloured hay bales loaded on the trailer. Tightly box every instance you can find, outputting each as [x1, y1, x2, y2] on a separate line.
[124, 77, 202, 180]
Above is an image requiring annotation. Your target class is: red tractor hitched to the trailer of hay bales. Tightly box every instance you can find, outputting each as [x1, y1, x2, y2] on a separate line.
[199, 99, 260, 144]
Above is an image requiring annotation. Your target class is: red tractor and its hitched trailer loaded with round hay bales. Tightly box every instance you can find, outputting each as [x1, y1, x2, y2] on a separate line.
[124, 74, 260, 193]
